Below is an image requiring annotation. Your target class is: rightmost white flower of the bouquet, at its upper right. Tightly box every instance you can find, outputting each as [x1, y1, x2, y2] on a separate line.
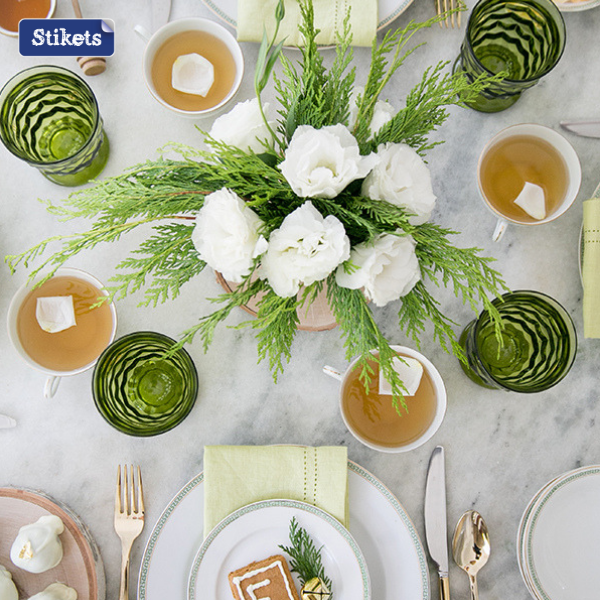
[362, 144, 436, 225]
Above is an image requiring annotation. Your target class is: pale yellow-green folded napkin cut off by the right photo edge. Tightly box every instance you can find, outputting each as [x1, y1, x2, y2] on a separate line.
[582, 196, 600, 338]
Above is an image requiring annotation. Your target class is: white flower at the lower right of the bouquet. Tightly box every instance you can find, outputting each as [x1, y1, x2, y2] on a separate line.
[335, 230, 421, 306]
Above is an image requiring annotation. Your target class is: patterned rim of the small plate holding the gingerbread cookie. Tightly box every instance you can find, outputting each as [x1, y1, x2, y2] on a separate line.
[188, 500, 371, 600]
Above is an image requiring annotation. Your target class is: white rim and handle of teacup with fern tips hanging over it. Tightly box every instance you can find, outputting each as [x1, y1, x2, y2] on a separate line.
[323, 346, 447, 453]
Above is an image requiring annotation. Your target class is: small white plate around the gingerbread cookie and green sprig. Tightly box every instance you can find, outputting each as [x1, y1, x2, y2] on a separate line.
[189, 500, 371, 600]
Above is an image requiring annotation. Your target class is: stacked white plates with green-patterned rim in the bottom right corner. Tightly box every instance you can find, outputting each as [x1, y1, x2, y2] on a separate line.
[517, 466, 600, 600]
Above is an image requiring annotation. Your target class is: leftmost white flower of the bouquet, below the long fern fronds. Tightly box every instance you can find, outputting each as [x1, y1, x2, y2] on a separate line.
[192, 188, 268, 283]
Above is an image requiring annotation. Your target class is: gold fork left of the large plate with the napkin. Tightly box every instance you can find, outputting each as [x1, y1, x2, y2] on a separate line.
[115, 465, 144, 600]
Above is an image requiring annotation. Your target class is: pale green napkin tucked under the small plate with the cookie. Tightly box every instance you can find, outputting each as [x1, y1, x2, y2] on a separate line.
[204, 446, 348, 537]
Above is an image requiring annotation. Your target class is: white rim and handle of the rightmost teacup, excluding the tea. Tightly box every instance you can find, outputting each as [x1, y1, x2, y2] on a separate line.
[477, 123, 581, 242]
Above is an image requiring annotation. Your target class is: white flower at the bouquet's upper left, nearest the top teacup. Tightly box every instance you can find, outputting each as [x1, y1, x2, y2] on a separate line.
[209, 98, 277, 154]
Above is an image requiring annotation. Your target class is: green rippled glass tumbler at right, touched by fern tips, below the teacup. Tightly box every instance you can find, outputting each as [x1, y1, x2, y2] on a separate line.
[460, 290, 577, 393]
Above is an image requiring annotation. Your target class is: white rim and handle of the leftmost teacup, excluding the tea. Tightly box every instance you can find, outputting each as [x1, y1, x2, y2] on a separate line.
[7, 267, 117, 398]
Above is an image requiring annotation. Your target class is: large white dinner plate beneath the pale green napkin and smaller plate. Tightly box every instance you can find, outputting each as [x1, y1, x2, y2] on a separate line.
[138, 462, 430, 600]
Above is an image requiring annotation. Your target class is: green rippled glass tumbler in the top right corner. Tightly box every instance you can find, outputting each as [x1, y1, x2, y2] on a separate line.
[454, 0, 566, 112]
